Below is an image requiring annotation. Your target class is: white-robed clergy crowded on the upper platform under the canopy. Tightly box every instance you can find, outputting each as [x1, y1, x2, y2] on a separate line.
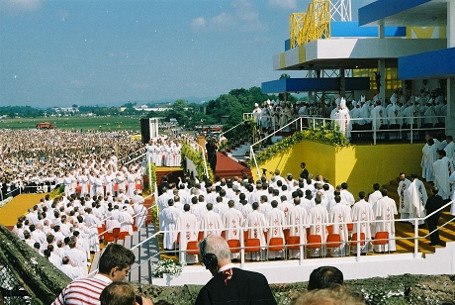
[252, 92, 447, 138]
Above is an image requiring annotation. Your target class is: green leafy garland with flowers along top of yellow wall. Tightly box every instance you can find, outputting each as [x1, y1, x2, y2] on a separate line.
[249, 125, 349, 166]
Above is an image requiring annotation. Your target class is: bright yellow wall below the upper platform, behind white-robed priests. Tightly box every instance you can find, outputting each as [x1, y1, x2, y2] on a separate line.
[252, 140, 423, 198]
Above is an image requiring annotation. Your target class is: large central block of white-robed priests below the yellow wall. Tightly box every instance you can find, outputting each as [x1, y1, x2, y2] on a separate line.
[157, 163, 442, 263]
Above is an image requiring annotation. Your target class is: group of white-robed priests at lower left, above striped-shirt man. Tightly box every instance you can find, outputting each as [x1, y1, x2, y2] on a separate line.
[13, 187, 147, 279]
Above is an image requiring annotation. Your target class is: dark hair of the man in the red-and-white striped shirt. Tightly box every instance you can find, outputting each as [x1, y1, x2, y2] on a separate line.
[98, 244, 136, 274]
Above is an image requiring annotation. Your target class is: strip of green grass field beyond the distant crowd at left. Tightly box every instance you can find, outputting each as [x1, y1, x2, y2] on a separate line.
[0, 116, 141, 132]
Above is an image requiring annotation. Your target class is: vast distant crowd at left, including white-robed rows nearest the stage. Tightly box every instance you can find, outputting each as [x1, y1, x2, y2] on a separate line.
[0, 129, 142, 200]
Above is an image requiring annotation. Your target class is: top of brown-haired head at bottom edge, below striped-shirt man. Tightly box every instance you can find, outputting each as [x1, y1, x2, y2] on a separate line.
[100, 282, 136, 305]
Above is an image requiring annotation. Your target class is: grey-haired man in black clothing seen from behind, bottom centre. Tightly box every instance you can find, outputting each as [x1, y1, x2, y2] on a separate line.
[196, 235, 277, 305]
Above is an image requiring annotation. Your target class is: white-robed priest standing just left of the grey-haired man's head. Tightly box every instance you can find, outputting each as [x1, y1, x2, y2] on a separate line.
[175, 204, 198, 264]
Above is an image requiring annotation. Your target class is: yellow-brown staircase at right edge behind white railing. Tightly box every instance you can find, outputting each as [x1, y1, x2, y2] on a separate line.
[382, 179, 455, 254]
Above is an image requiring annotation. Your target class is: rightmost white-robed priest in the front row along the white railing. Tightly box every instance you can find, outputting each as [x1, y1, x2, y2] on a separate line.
[373, 189, 398, 251]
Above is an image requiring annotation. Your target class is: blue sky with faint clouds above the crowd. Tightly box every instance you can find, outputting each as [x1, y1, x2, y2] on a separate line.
[0, 0, 372, 107]
